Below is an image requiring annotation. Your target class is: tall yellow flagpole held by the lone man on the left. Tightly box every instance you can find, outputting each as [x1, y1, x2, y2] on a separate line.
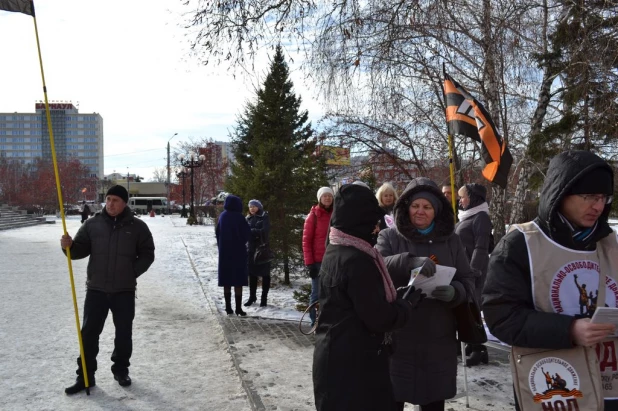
[32, 15, 90, 395]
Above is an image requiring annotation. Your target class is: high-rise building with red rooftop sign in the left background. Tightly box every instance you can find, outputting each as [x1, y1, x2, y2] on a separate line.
[0, 103, 104, 178]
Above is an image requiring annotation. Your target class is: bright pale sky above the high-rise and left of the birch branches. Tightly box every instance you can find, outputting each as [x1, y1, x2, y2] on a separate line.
[0, 0, 321, 180]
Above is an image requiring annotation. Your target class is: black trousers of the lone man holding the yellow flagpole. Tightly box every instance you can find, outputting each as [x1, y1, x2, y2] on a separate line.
[77, 290, 135, 376]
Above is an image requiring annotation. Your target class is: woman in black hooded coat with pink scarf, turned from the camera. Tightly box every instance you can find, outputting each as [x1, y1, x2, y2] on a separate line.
[313, 184, 420, 411]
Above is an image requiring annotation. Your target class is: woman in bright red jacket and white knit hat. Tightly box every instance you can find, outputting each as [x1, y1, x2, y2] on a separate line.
[303, 187, 334, 327]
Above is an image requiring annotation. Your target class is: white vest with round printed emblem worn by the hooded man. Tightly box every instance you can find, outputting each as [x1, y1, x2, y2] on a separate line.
[516, 222, 618, 399]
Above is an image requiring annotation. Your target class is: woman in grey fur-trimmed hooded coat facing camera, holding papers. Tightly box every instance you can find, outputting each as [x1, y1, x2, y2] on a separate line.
[376, 177, 476, 411]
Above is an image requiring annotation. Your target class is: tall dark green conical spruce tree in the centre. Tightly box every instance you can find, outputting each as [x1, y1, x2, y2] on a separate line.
[226, 46, 326, 284]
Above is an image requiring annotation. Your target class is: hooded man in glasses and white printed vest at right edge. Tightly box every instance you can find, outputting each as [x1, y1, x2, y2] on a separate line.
[482, 151, 618, 410]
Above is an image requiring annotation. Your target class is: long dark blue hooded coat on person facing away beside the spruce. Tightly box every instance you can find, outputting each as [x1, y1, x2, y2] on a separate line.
[215, 195, 251, 287]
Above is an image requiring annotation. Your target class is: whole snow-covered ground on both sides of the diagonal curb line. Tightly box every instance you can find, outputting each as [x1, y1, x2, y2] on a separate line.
[0, 216, 536, 411]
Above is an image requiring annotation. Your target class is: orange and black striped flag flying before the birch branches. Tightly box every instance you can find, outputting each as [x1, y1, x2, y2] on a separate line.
[444, 72, 513, 188]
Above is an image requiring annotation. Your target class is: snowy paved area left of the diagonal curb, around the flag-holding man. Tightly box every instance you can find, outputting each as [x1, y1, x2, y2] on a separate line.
[0, 219, 251, 411]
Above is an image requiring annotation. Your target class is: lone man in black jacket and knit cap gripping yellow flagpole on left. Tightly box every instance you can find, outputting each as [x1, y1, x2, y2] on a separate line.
[60, 185, 154, 394]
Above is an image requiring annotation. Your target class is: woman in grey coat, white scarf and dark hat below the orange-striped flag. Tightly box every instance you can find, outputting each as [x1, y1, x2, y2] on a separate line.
[455, 183, 491, 366]
